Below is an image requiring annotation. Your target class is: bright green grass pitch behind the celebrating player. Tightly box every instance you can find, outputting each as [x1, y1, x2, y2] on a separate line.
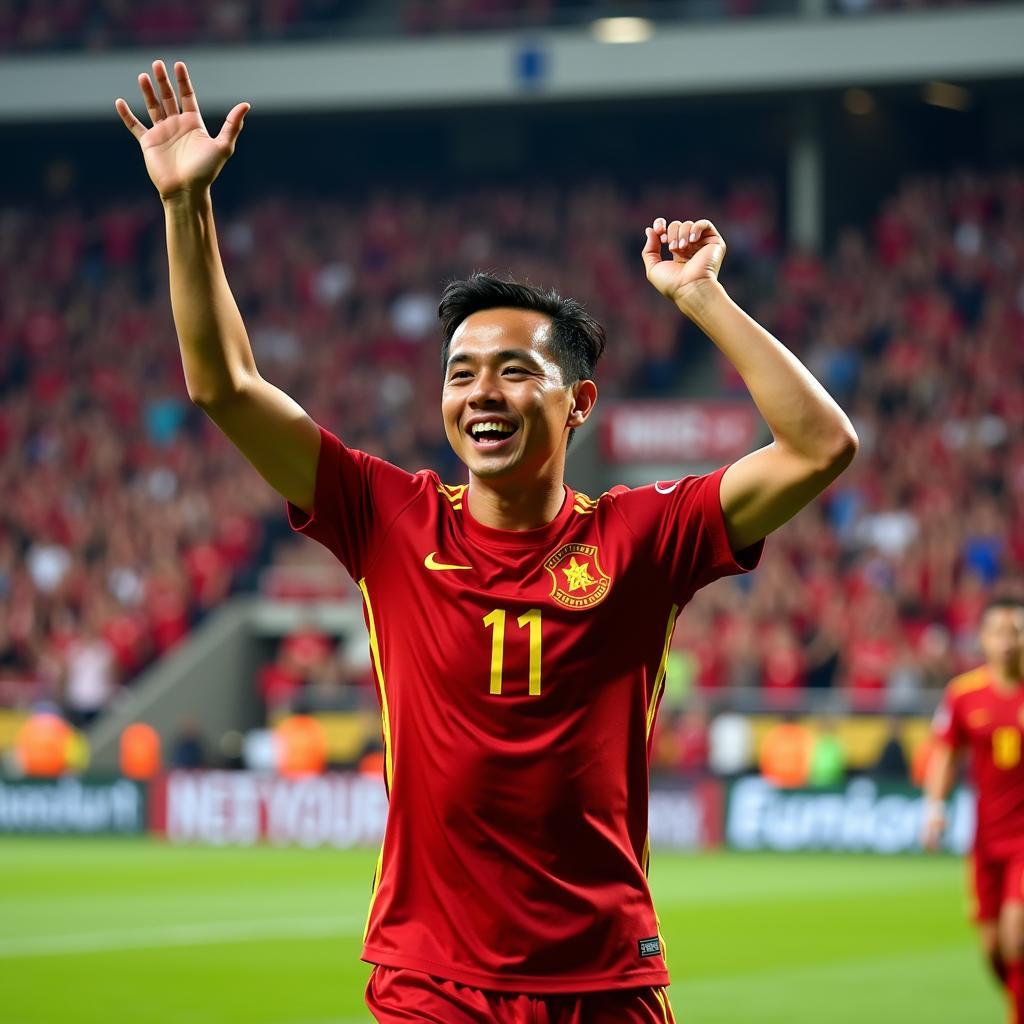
[0, 839, 1005, 1024]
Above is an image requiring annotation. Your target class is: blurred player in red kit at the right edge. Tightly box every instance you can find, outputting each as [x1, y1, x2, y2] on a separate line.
[924, 598, 1024, 1024]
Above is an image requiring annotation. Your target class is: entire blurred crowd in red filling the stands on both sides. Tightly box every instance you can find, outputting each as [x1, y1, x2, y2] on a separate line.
[0, 173, 1024, 722]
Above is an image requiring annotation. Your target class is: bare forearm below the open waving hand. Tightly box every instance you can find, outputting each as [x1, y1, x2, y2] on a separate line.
[164, 190, 256, 406]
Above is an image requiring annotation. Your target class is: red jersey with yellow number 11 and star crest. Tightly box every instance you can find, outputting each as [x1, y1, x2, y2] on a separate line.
[288, 428, 761, 994]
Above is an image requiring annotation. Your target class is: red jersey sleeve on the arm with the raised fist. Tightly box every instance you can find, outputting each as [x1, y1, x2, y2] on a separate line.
[611, 466, 764, 602]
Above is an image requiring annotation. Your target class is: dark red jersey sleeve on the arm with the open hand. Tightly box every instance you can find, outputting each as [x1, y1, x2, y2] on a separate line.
[286, 427, 427, 580]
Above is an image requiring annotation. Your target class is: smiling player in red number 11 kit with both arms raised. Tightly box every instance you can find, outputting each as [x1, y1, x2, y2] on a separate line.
[117, 61, 856, 1024]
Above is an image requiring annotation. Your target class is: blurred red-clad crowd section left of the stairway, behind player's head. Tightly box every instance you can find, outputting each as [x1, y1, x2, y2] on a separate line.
[0, 176, 774, 722]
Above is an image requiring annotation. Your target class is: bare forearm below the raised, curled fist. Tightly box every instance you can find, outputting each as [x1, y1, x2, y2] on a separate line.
[677, 282, 856, 464]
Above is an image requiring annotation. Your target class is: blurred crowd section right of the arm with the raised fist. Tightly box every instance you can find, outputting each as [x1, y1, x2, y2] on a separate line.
[676, 172, 1024, 709]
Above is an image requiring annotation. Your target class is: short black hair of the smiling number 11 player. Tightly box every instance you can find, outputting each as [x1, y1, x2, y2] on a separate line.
[437, 270, 605, 447]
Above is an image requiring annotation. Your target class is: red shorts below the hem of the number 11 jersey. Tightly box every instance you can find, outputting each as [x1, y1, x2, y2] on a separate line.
[367, 965, 676, 1024]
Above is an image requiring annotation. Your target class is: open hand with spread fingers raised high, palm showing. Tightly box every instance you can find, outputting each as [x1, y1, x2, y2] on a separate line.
[114, 60, 249, 199]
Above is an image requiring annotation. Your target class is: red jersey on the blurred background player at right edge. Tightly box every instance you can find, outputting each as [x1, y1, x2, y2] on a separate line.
[935, 666, 1024, 858]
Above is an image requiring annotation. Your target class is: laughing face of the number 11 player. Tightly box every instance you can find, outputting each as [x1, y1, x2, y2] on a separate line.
[441, 309, 573, 477]
